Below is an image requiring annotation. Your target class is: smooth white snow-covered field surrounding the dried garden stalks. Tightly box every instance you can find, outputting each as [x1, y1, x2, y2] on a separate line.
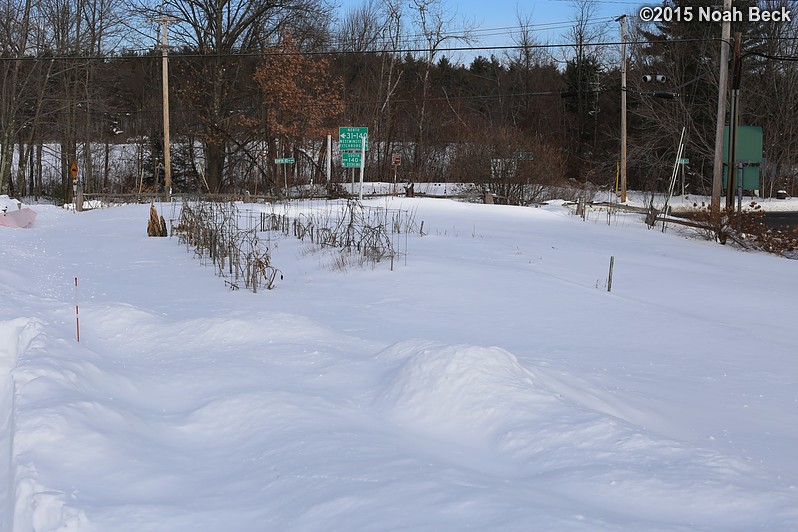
[0, 198, 798, 532]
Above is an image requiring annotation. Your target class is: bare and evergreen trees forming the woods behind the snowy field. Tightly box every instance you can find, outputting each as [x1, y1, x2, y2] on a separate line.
[0, 0, 798, 203]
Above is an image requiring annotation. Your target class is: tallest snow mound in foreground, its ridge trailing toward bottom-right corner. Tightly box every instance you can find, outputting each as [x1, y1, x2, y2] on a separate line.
[379, 341, 798, 529]
